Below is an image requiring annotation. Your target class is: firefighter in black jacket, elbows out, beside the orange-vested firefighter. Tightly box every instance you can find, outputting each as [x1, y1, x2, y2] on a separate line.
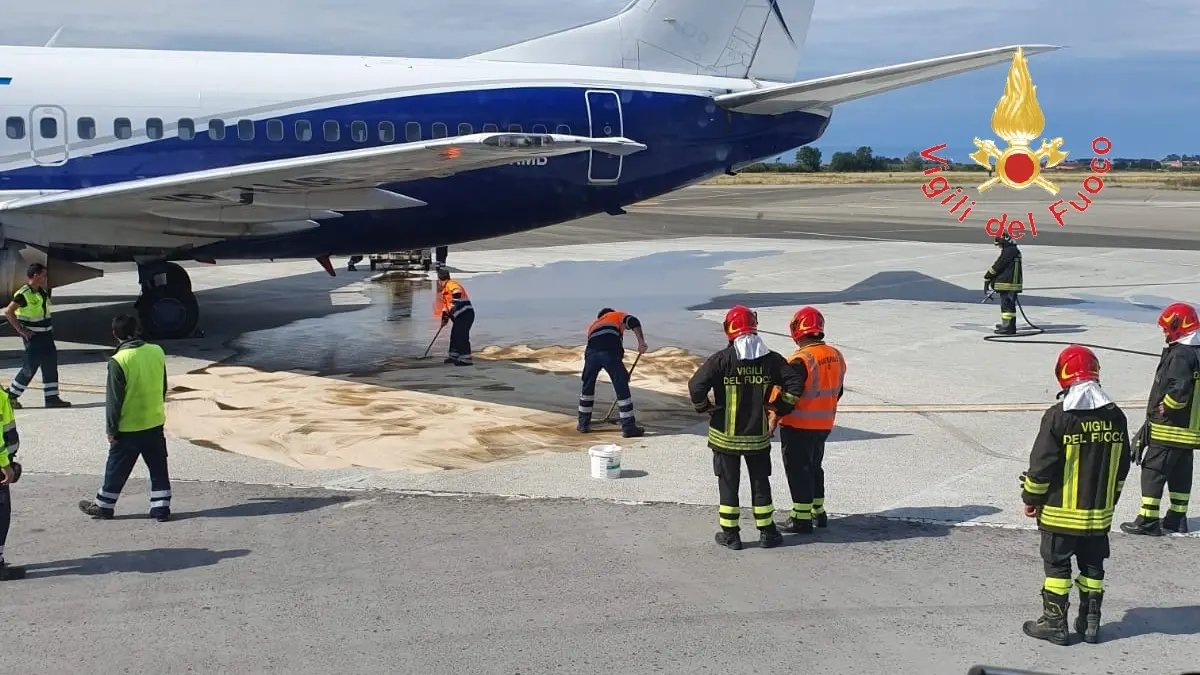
[688, 305, 804, 550]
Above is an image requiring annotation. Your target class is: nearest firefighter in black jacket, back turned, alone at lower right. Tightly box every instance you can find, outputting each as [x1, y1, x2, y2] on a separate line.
[1021, 345, 1130, 645]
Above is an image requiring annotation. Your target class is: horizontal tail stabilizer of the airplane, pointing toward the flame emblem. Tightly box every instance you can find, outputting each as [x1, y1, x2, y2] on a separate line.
[713, 44, 1060, 115]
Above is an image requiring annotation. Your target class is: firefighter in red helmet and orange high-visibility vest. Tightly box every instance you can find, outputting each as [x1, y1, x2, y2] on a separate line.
[779, 307, 846, 534]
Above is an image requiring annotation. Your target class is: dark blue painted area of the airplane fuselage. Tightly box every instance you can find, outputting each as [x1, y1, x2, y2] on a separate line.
[0, 88, 828, 259]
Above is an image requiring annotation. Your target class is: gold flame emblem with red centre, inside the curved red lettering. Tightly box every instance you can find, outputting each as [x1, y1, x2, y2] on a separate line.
[968, 48, 1068, 195]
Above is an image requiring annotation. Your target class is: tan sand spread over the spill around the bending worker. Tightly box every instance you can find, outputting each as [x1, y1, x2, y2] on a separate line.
[159, 346, 702, 472]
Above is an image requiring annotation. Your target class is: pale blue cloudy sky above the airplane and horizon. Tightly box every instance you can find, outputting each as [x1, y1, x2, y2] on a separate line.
[0, 0, 1200, 160]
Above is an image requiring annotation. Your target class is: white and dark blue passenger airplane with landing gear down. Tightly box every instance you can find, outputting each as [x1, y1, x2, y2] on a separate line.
[0, 0, 1058, 339]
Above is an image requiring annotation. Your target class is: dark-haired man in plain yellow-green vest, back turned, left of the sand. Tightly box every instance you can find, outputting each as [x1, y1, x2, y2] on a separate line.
[79, 315, 170, 522]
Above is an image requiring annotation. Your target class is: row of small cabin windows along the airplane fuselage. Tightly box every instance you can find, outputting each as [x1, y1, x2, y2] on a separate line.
[5, 117, 571, 143]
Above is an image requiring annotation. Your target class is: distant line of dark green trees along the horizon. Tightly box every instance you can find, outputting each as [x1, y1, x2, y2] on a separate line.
[742, 145, 1200, 174]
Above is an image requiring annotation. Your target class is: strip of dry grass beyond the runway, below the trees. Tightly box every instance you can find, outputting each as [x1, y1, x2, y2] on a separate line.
[706, 171, 1200, 190]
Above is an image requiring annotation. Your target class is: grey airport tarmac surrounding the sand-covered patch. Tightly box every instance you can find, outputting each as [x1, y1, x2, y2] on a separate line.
[0, 184, 1200, 675]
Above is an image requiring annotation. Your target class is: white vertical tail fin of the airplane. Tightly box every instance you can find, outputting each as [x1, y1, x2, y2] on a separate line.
[468, 0, 816, 82]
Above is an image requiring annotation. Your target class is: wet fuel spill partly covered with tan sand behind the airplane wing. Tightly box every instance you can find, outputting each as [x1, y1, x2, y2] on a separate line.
[168, 251, 770, 472]
